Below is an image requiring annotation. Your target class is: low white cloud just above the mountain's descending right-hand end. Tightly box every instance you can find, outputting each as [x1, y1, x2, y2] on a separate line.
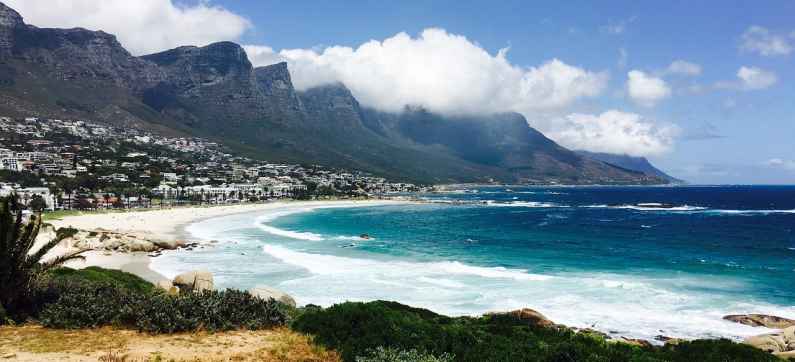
[547, 110, 680, 156]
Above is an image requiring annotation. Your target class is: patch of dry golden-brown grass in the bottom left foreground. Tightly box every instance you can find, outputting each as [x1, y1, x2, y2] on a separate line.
[0, 325, 340, 362]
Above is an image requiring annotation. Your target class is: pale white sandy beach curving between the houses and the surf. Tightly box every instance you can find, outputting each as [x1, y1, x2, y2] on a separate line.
[43, 200, 401, 282]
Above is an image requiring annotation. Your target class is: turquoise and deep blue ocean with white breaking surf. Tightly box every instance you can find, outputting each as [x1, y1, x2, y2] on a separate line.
[153, 186, 795, 339]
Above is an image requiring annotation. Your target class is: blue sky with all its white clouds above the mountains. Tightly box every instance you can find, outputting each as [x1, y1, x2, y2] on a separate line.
[6, 0, 795, 184]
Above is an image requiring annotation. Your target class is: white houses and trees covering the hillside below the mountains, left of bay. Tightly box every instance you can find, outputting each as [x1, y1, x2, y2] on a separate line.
[0, 117, 426, 208]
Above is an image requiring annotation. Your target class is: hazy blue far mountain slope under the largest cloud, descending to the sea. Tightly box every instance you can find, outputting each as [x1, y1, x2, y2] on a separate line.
[366, 109, 659, 184]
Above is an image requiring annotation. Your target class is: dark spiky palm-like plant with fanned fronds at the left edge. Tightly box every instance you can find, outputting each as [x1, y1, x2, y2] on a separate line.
[0, 195, 87, 313]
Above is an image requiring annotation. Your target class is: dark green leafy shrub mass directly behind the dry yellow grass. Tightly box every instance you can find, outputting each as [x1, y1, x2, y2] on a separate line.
[39, 282, 288, 333]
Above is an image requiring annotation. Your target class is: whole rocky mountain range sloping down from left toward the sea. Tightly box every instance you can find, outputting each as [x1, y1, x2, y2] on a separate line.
[0, 3, 671, 184]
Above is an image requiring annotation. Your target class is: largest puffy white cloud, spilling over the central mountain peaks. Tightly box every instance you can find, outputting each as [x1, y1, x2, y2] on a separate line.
[245, 28, 608, 116]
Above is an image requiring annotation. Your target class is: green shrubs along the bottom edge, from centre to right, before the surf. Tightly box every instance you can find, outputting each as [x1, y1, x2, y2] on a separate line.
[293, 301, 780, 362]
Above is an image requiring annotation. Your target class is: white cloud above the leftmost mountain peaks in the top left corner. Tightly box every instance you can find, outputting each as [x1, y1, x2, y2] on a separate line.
[5, 0, 251, 55]
